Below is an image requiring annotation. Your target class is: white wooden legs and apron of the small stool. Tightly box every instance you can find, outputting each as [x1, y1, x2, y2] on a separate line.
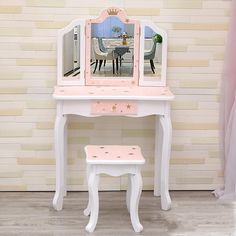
[84, 147, 145, 232]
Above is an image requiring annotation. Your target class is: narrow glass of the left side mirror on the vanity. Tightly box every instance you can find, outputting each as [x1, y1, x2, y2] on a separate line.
[63, 26, 80, 77]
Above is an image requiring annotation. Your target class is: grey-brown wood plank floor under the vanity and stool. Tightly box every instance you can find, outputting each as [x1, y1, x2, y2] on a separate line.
[0, 191, 236, 236]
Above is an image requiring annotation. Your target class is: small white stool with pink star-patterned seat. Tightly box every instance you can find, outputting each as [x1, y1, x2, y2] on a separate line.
[84, 145, 145, 232]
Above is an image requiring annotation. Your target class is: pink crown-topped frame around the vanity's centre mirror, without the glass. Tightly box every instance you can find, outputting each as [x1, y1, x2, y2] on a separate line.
[85, 7, 140, 86]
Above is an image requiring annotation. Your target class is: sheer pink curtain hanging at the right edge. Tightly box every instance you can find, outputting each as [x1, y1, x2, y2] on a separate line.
[214, 0, 236, 200]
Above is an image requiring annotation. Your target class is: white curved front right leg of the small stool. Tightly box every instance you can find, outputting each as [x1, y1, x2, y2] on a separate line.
[130, 172, 143, 233]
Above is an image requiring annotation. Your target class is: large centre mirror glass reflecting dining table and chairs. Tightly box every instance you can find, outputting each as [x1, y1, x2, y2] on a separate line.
[90, 16, 134, 78]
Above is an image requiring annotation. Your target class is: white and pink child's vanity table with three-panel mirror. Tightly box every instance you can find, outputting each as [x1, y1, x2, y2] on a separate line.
[53, 7, 174, 210]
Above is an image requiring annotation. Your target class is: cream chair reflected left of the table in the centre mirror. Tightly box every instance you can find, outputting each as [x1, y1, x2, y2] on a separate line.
[93, 38, 118, 74]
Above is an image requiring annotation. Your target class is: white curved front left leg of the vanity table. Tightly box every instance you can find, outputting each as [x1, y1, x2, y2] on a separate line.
[53, 115, 67, 211]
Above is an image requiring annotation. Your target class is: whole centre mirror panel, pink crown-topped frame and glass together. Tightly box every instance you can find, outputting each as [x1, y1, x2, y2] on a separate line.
[86, 9, 139, 86]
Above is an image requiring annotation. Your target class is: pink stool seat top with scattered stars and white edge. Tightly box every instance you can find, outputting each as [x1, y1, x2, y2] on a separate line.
[85, 145, 145, 164]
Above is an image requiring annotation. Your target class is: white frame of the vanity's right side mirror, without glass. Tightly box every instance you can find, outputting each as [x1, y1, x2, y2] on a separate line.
[139, 21, 167, 86]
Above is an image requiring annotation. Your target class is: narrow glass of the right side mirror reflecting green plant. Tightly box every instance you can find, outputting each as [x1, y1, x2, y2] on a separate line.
[144, 26, 162, 79]
